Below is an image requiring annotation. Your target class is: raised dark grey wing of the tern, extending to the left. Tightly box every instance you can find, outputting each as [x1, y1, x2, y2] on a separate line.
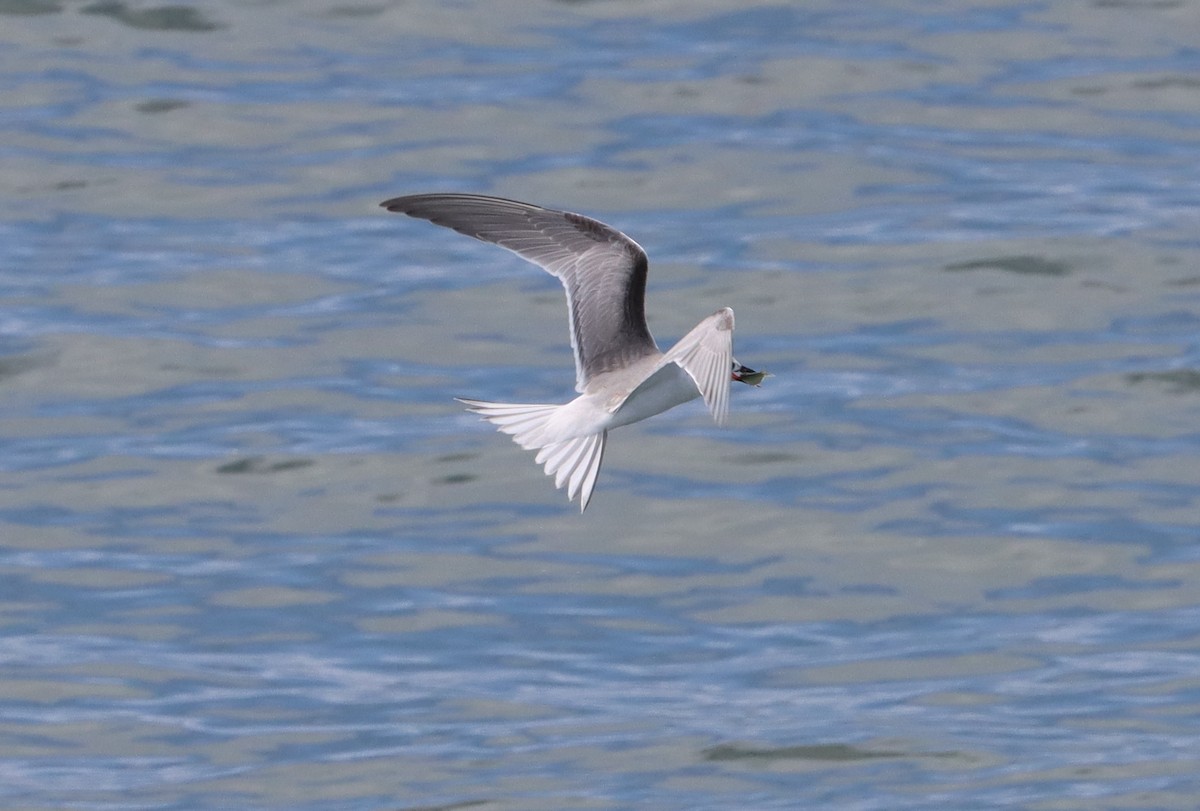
[380, 194, 658, 392]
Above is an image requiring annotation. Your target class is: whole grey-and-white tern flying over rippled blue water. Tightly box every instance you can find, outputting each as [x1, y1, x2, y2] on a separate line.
[379, 193, 767, 513]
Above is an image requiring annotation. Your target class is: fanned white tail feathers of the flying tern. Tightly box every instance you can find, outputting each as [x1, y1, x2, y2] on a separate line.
[456, 397, 608, 512]
